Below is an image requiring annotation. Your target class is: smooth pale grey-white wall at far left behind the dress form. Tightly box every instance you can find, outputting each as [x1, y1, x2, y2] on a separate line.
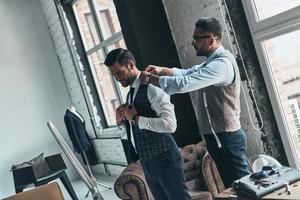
[0, 0, 77, 199]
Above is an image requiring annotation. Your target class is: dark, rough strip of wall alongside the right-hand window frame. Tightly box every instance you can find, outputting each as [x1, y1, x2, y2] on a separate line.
[226, 0, 288, 165]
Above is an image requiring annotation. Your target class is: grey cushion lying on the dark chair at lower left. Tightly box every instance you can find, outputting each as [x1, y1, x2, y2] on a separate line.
[11, 153, 51, 179]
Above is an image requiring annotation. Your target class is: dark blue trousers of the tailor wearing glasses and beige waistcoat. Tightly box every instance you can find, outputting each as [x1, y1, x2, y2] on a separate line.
[204, 129, 249, 188]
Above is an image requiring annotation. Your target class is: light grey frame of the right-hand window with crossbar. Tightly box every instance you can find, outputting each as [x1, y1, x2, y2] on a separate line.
[242, 0, 300, 168]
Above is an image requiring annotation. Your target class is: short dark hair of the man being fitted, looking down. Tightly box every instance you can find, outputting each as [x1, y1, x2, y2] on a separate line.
[104, 48, 135, 67]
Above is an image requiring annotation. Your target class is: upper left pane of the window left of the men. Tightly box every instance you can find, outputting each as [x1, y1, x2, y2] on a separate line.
[73, 0, 99, 51]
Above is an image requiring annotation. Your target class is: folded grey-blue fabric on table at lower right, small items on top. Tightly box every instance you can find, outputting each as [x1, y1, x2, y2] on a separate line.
[233, 167, 300, 198]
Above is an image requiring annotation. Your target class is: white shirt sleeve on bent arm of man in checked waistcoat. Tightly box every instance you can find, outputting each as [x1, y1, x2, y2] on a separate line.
[138, 84, 177, 133]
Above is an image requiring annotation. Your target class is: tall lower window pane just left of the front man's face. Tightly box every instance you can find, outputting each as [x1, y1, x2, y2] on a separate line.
[88, 50, 120, 126]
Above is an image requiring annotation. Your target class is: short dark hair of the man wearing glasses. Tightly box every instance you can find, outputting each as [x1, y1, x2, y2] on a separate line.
[195, 17, 222, 40]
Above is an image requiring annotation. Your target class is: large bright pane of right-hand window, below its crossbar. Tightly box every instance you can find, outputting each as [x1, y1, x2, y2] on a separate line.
[263, 30, 300, 164]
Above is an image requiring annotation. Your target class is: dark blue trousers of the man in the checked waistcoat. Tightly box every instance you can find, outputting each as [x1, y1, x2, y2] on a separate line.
[141, 149, 190, 200]
